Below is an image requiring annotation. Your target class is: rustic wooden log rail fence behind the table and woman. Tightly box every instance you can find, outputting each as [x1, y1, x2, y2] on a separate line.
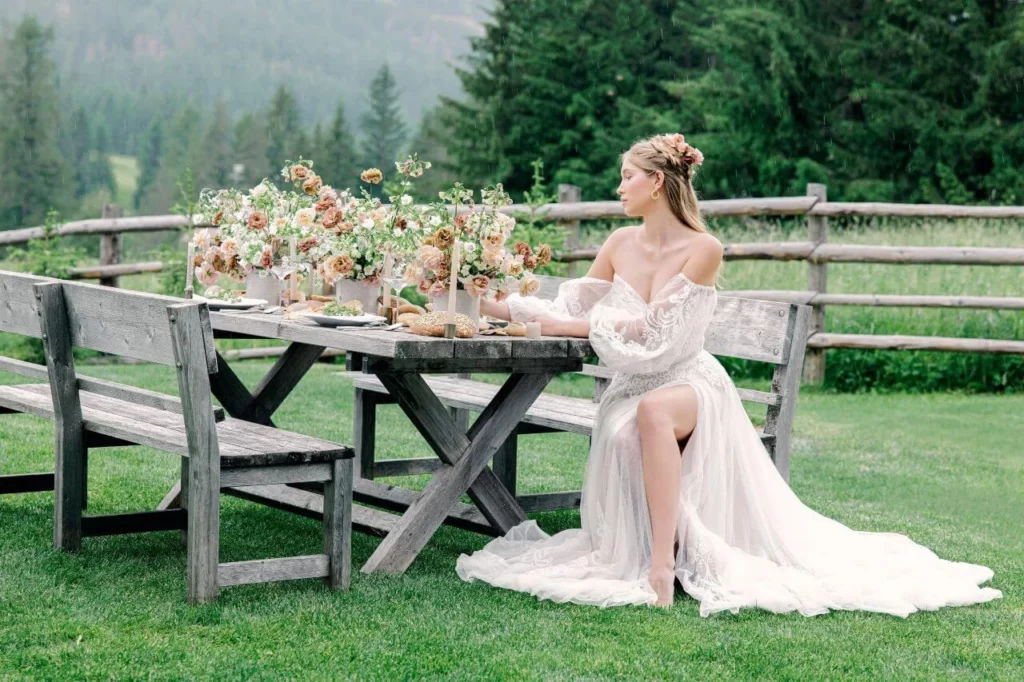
[0, 189, 1024, 383]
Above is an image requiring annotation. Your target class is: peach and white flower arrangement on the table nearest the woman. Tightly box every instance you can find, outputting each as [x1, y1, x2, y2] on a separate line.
[407, 182, 551, 298]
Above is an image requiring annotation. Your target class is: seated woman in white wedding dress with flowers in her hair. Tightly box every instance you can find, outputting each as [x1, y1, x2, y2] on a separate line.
[457, 134, 1002, 616]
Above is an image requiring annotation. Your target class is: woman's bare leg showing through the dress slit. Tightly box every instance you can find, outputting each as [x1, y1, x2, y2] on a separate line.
[637, 386, 697, 606]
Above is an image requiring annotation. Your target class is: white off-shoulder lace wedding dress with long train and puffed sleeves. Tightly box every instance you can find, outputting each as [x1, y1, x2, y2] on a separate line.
[457, 273, 1002, 616]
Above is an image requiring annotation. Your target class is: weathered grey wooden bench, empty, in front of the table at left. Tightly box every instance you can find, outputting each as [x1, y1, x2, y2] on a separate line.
[0, 271, 353, 602]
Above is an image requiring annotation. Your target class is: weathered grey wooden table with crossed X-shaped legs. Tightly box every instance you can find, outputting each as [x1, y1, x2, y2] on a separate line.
[200, 312, 591, 573]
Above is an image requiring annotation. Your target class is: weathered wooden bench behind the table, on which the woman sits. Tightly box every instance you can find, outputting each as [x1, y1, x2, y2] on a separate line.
[350, 278, 810, 511]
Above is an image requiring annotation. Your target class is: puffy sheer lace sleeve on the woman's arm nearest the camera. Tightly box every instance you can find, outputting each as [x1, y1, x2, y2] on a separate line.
[590, 274, 718, 374]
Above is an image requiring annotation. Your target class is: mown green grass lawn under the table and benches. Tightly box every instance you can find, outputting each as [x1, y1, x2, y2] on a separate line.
[0, 361, 1024, 680]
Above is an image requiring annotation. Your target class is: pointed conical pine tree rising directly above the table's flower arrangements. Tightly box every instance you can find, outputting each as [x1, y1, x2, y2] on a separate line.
[359, 63, 408, 191]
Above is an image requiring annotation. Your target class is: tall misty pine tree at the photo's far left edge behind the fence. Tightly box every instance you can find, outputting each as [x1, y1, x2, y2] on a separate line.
[0, 16, 72, 227]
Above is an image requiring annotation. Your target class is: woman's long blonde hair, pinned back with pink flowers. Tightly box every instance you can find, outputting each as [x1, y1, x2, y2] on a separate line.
[622, 135, 708, 232]
